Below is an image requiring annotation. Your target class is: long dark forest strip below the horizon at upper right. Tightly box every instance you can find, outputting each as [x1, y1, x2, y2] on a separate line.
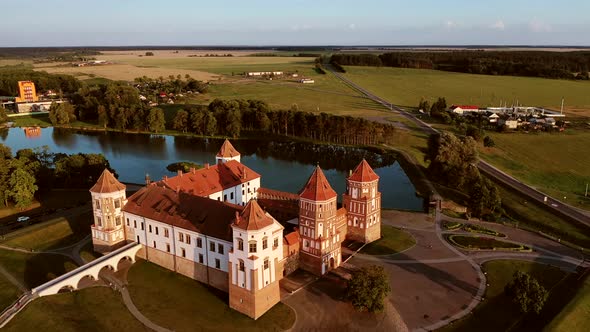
[330, 51, 590, 80]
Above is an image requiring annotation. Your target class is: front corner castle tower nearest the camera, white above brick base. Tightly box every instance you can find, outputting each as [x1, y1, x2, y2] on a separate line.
[228, 200, 283, 319]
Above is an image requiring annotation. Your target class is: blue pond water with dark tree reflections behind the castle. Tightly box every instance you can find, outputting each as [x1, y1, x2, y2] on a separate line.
[0, 128, 423, 211]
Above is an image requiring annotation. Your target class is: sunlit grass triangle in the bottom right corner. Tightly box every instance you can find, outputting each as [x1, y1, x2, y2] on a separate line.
[545, 277, 590, 332]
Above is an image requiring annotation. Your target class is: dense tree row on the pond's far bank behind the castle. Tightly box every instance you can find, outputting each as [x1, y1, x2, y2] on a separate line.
[172, 99, 395, 145]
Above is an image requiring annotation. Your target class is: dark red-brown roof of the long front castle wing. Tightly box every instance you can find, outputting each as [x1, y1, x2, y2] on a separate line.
[123, 183, 243, 242]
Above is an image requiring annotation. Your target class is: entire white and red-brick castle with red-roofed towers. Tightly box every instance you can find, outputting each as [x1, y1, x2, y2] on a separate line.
[90, 140, 381, 319]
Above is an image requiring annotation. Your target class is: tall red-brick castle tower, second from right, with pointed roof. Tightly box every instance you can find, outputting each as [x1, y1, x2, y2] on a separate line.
[299, 166, 345, 275]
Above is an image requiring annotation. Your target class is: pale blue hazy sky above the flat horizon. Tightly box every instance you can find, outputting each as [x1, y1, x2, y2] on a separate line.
[0, 0, 590, 47]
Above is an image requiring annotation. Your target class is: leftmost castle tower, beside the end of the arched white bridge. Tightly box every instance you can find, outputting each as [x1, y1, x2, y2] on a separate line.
[90, 169, 127, 253]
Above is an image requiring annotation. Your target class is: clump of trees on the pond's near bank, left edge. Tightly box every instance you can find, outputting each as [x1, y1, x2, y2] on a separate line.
[0, 143, 113, 209]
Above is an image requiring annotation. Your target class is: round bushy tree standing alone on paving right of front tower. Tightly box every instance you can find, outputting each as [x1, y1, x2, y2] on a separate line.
[347, 265, 391, 312]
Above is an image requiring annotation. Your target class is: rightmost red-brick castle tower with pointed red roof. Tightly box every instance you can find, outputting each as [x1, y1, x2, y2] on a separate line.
[342, 159, 381, 243]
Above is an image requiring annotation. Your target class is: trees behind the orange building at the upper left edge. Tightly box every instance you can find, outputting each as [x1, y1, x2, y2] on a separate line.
[0, 65, 82, 96]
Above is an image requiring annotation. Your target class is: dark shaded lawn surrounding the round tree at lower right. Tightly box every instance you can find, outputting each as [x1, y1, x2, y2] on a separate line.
[439, 260, 566, 332]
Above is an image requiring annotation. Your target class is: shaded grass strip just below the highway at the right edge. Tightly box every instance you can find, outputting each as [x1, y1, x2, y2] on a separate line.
[498, 186, 590, 248]
